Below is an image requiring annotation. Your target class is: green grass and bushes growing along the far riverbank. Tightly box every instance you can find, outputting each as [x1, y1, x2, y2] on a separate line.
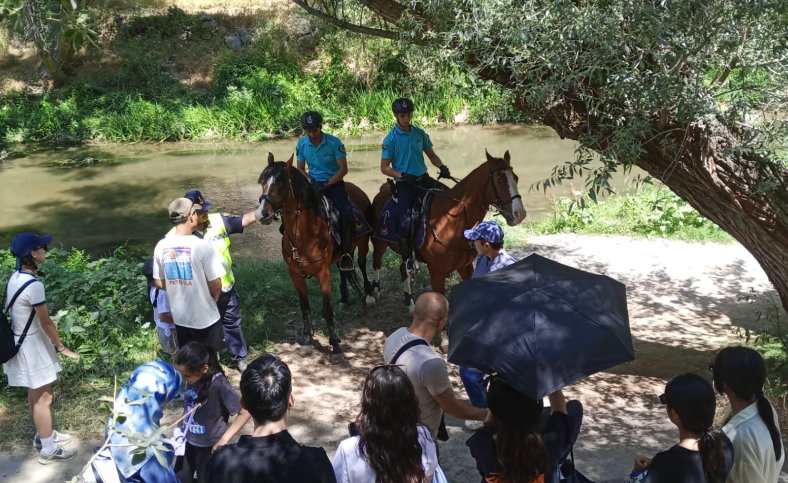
[0, 8, 522, 144]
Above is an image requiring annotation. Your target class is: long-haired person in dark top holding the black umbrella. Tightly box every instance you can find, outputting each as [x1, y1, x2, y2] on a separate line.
[466, 376, 585, 483]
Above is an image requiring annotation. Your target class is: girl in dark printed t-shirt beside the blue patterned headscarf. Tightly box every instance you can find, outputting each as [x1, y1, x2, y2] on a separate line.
[173, 341, 251, 483]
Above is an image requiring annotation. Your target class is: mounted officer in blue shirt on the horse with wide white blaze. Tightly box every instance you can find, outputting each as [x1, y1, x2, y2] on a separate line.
[380, 97, 451, 273]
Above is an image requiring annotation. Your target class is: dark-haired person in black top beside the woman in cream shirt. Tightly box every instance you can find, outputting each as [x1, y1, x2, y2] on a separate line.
[634, 373, 733, 483]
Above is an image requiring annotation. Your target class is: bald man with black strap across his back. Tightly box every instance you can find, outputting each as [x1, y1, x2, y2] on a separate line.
[383, 292, 487, 441]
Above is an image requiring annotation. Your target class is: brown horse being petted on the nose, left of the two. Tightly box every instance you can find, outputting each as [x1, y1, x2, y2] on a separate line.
[257, 153, 374, 363]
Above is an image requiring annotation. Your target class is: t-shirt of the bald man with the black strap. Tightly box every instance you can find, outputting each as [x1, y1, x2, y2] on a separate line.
[383, 327, 451, 441]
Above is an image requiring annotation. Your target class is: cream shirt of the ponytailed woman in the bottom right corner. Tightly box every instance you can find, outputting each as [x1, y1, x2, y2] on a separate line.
[722, 402, 785, 483]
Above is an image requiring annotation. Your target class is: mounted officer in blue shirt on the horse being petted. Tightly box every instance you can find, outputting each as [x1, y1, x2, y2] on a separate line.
[296, 111, 355, 271]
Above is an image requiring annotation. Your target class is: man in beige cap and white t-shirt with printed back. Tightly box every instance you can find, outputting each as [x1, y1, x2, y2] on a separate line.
[153, 198, 224, 352]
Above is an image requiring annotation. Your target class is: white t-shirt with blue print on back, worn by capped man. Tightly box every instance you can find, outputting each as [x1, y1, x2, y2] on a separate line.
[153, 235, 224, 329]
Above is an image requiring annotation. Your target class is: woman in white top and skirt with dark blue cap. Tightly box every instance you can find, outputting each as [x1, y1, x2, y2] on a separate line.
[3, 233, 79, 464]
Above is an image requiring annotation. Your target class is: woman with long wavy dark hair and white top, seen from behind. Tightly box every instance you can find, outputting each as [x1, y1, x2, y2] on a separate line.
[333, 365, 438, 483]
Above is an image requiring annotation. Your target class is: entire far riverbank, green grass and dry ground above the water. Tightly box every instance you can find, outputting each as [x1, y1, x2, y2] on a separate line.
[0, 2, 525, 145]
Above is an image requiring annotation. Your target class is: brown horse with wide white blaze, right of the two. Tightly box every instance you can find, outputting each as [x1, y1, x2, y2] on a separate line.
[372, 151, 525, 310]
